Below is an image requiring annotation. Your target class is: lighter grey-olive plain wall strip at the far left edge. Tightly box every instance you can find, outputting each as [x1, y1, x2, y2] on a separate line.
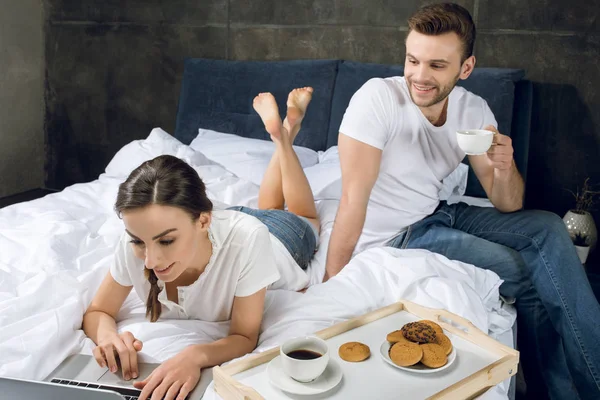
[0, 0, 44, 197]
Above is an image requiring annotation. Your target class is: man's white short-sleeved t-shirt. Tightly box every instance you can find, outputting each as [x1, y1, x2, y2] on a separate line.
[340, 77, 497, 254]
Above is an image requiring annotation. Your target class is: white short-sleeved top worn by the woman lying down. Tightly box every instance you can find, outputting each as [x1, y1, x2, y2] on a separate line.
[110, 211, 284, 322]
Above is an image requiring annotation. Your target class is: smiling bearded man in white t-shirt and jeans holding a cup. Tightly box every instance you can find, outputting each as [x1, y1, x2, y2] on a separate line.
[325, 4, 600, 399]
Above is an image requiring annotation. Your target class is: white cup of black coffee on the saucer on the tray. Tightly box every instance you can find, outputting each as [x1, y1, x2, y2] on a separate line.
[279, 336, 329, 383]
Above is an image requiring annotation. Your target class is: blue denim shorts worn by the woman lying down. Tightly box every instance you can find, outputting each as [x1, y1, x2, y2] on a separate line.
[228, 206, 318, 269]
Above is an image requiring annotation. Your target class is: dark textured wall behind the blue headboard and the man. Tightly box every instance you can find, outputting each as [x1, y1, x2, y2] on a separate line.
[46, 0, 600, 220]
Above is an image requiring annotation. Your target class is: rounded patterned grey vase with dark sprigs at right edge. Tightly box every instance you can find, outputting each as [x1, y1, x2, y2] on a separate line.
[563, 178, 600, 251]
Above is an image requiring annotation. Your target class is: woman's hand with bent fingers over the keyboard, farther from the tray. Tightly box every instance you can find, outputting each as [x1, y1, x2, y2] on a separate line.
[93, 332, 142, 380]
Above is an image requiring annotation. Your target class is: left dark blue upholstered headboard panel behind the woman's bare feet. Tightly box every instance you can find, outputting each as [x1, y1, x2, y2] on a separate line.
[175, 58, 338, 150]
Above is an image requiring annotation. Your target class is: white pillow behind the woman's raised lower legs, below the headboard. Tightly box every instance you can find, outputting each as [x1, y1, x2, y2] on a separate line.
[190, 129, 319, 185]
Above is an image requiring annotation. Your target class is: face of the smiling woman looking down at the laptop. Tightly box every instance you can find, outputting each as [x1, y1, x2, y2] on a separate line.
[122, 204, 210, 282]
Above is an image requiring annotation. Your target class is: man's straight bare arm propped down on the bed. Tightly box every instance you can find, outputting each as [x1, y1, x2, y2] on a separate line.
[325, 132, 382, 280]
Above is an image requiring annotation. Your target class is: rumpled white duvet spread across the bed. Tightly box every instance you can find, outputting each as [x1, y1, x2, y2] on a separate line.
[0, 129, 515, 399]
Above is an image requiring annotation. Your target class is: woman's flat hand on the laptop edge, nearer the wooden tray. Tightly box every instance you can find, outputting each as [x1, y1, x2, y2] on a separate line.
[133, 346, 202, 400]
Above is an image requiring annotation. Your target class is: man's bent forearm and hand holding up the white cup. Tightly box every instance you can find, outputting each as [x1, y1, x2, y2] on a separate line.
[469, 126, 525, 212]
